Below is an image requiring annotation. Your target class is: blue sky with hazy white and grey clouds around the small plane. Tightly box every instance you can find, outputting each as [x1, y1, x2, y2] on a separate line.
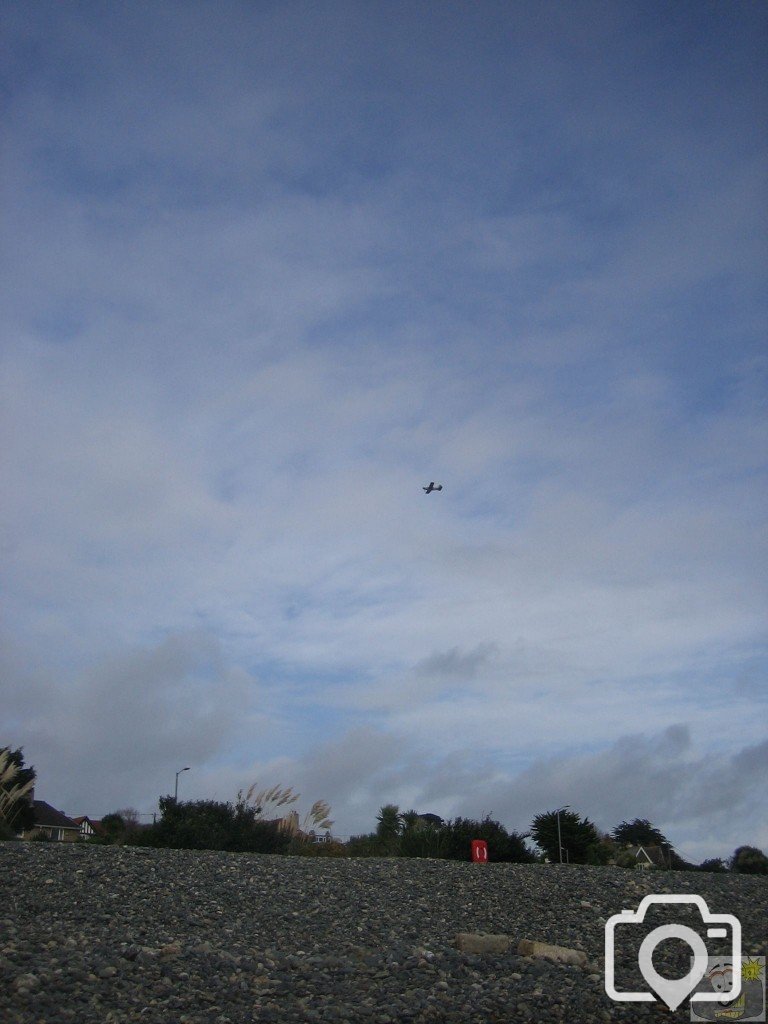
[0, 0, 768, 862]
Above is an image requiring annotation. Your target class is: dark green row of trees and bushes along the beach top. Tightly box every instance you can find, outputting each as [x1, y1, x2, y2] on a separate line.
[0, 746, 768, 874]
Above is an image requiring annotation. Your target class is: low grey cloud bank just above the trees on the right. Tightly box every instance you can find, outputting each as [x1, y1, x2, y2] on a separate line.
[176, 724, 768, 862]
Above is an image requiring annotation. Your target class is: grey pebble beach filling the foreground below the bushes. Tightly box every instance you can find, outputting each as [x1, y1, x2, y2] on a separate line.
[0, 843, 768, 1024]
